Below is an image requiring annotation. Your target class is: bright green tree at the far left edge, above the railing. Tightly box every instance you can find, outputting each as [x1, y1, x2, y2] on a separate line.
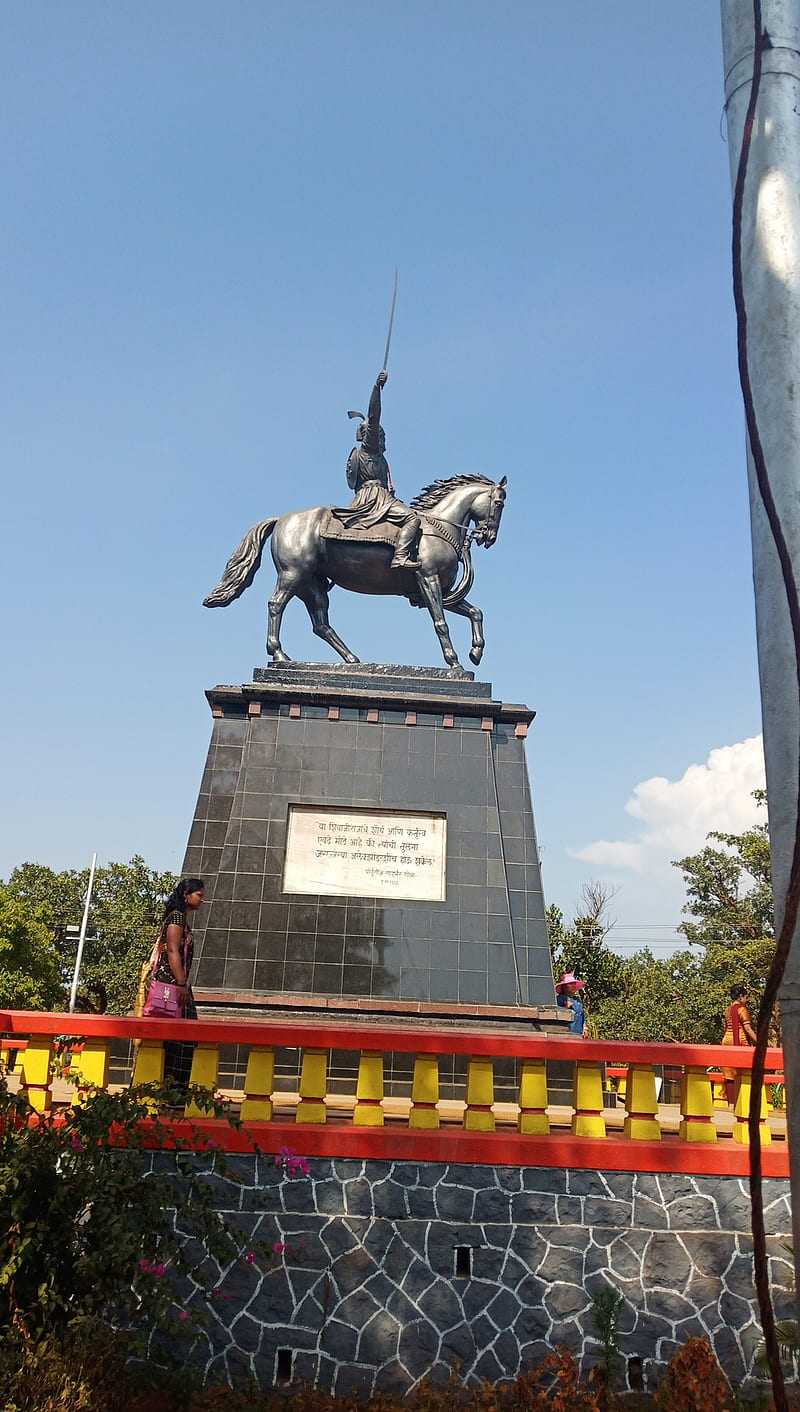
[0, 884, 63, 1010]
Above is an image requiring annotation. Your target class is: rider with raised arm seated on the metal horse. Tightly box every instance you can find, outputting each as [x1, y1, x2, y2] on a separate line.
[332, 369, 420, 569]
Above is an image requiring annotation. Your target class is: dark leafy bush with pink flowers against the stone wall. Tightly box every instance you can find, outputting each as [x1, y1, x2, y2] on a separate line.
[0, 1080, 290, 1339]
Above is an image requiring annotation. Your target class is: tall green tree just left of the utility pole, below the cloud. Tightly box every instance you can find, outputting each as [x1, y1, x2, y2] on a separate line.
[673, 789, 773, 946]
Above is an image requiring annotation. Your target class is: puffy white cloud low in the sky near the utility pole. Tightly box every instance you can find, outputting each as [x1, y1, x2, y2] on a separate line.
[567, 736, 765, 874]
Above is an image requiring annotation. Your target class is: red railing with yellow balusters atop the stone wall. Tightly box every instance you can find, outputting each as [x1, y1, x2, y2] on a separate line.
[0, 1011, 789, 1176]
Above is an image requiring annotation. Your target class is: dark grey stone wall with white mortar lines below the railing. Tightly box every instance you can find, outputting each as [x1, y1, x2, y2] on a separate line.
[151, 1154, 793, 1394]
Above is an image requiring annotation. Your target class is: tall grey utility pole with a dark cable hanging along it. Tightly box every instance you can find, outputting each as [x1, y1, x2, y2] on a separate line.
[721, 0, 800, 1289]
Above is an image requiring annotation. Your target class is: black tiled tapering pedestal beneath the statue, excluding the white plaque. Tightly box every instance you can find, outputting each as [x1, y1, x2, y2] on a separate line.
[183, 662, 554, 1008]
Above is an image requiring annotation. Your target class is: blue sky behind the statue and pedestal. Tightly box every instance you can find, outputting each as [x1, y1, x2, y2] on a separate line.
[0, 0, 760, 949]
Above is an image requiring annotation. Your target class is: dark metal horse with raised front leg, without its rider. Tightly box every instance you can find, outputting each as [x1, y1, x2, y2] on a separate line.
[203, 474, 507, 675]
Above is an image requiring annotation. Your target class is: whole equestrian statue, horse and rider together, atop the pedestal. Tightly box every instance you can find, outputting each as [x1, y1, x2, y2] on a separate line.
[203, 367, 507, 675]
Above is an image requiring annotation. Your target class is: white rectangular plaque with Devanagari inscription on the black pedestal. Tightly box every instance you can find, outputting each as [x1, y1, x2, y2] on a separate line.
[284, 803, 447, 902]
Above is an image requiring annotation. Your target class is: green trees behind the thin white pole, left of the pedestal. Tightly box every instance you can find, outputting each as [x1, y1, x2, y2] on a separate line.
[6, 856, 178, 1015]
